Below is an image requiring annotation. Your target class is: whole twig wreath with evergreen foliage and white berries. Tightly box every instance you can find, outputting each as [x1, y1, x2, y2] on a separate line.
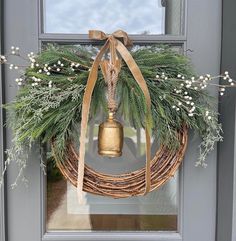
[1, 30, 235, 198]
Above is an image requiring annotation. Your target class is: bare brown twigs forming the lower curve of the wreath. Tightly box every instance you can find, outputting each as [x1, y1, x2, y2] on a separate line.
[52, 127, 188, 198]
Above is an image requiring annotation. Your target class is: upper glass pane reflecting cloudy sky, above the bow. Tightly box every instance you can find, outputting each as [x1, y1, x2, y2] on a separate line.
[43, 0, 183, 35]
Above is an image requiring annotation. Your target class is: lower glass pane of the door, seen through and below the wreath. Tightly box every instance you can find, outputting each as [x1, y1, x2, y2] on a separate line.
[46, 125, 179, 231]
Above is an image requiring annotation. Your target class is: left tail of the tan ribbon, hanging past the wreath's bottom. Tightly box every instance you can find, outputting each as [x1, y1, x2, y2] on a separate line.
[77, 41, 109, 204]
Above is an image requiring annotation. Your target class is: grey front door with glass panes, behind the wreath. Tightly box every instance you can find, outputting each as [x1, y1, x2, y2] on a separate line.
[0, 0, 221, 241]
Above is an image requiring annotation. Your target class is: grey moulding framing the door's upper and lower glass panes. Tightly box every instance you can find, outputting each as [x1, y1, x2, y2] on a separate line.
[38, 0, 187, 241]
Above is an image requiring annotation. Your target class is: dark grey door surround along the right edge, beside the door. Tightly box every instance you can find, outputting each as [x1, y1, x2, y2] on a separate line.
[217, 0, 236, 241]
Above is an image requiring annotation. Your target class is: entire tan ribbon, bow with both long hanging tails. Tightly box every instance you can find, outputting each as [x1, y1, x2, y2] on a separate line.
[77, 30, 151, 202]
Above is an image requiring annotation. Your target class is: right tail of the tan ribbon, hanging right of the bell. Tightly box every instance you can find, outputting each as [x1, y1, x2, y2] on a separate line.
[116, 40, 151, 195]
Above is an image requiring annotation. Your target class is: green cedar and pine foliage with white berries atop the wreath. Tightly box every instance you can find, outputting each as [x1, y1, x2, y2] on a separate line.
[1, 45, 235, 186]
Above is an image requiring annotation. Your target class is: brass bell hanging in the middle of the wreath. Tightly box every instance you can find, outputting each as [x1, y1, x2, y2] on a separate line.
[98, 112, 124, 157]
